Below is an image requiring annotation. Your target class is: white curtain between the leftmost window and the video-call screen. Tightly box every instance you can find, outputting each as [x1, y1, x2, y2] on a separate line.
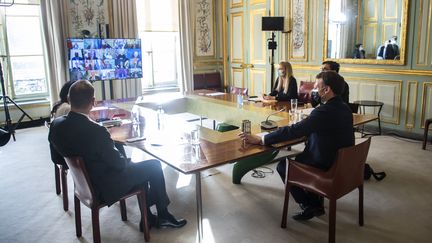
[40, 0, 68, 105]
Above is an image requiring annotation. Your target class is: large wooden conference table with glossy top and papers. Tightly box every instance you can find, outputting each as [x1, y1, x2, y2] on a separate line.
[90, 91, 378, 242]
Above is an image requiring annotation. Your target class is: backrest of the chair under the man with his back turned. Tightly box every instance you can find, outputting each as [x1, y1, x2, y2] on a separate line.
[65, 156, 97, 208]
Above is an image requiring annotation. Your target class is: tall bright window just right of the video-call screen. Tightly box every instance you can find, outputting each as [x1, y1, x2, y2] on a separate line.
[137, 0, 180, 89]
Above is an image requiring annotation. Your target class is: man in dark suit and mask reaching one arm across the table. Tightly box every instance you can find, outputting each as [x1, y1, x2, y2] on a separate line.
[240, 72, 354, 220]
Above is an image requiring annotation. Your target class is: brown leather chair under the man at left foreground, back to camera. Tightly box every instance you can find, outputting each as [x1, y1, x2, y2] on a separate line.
[65, 157, 150, 242]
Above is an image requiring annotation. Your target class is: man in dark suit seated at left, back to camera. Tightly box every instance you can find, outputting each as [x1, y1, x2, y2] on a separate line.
[48, 81, 186, 229]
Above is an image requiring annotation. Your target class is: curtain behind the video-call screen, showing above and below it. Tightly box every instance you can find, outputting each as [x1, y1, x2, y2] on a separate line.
[110, 0, 142, 99]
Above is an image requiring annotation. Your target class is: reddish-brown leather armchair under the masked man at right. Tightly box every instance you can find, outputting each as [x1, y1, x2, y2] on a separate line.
[281, 138, 370, 243]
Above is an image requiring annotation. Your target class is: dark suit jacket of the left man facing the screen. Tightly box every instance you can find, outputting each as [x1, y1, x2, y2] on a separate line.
[48, 111, 134, 205]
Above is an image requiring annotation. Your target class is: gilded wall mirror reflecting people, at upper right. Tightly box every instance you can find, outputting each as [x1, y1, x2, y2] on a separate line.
[323, 0, 408, 65]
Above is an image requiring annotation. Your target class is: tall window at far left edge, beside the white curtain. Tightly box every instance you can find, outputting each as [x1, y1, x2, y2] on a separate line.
[0, 0, 48, 99]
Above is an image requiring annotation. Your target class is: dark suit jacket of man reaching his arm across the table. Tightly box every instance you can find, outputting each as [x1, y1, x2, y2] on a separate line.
[264, 96, 354, 170]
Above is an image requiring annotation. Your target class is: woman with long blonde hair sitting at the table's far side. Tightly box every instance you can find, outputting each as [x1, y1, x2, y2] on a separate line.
[263, 62, 298, 101]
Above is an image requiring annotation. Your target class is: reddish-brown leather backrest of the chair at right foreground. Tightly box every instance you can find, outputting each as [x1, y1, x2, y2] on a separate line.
[329, 138, 371, 198]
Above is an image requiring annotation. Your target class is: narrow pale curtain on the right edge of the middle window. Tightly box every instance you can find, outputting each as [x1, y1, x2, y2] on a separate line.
[179, 0, 195, 92]
